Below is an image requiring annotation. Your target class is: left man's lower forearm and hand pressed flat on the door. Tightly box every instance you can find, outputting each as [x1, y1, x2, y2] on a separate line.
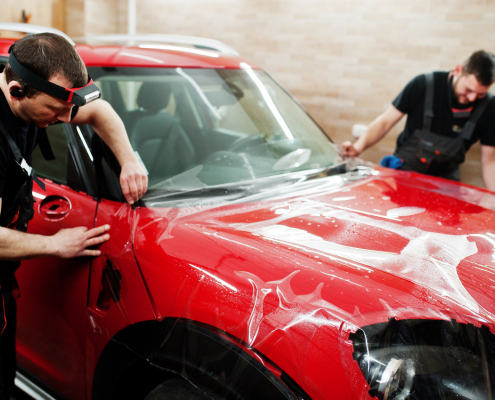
[0, 198, 110, 261]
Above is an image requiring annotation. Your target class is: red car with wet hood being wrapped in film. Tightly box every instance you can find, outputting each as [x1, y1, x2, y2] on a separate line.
[0, 24, 495, 400]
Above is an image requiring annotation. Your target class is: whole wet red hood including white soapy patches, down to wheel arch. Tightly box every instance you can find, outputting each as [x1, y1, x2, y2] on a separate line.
[134, 169, 495, 398]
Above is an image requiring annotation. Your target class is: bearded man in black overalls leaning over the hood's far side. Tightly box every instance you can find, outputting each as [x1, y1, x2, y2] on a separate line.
[342, 50, 495, 190]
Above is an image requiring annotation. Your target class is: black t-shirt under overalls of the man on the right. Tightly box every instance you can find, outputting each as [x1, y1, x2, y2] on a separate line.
[392, 71, 495, 150]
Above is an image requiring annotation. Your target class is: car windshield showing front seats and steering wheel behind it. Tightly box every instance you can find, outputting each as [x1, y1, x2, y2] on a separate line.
[89, 65, 341, 193]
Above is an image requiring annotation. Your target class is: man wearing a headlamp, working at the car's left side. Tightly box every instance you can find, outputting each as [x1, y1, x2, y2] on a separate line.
[0, 33, 148, 400]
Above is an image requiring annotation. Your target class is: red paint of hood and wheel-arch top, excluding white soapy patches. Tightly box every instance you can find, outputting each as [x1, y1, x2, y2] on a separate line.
[129, 170, 495, 399]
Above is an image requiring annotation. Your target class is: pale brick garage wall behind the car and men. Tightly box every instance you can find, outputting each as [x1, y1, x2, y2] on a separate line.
[2, 0, 495, 186]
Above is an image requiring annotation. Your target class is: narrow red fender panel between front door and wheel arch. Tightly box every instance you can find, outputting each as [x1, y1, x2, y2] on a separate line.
[86, 199, 157, 393]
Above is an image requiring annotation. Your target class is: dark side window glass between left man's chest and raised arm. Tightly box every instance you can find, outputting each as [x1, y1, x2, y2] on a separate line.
[32, 124, 69, 185]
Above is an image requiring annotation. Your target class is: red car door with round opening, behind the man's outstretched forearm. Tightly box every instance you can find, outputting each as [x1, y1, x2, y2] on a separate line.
[16, 180, 97, 399]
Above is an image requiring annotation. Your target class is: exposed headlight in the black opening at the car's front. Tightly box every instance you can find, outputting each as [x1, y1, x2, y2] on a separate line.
[349, 319, 495, 400]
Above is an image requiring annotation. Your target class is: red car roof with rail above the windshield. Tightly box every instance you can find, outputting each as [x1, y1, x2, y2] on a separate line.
[0, 39, 259, 69]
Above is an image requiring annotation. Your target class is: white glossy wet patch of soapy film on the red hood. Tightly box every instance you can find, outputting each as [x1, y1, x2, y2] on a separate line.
[235, 200, 495, 314]
